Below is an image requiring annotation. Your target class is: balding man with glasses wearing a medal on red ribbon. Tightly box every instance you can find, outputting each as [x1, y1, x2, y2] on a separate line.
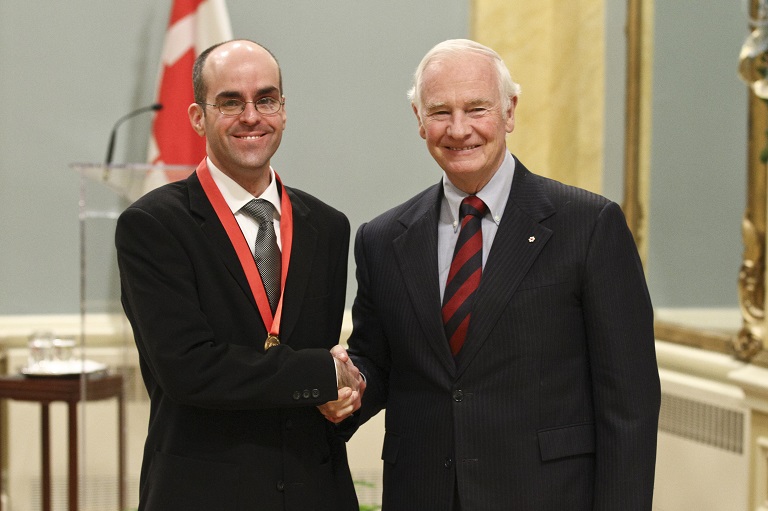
[116, 40, 365, 511]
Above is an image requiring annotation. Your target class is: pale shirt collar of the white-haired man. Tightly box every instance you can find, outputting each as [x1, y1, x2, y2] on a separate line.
[443, 152, 515, 232]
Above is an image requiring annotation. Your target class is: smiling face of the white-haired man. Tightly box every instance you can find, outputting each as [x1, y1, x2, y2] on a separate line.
[413, 52, 517, 194]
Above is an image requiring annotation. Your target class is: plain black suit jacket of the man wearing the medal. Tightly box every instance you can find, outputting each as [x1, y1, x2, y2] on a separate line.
[116, 174, 358, 511]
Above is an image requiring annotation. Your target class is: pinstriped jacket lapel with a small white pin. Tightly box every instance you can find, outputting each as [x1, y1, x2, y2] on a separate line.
[457, 160, 555, 374]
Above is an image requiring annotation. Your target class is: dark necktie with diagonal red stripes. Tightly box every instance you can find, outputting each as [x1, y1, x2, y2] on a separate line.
[443, 195, 488, 356]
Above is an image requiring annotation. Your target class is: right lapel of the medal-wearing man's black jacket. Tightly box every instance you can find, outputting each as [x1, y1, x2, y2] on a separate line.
[280, 187, 318, 344]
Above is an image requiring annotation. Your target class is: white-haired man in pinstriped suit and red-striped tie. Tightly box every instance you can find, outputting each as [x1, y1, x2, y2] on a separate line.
[349, 40, 660, 511]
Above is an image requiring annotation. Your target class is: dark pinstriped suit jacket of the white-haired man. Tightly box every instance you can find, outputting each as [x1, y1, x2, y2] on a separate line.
[349, 157, 660, 511]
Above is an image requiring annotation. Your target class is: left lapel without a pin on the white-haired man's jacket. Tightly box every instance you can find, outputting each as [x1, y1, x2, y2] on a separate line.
[393, 184, 456, 373]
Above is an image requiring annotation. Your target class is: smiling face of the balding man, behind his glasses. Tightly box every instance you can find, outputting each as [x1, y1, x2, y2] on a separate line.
[189, 41, 286, 193]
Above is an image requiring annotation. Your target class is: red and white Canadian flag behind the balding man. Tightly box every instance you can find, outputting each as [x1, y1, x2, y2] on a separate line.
[144, 0, 232, 192]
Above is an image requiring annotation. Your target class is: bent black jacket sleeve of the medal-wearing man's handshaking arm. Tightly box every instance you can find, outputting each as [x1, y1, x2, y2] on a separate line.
[115, 207, 337, 409]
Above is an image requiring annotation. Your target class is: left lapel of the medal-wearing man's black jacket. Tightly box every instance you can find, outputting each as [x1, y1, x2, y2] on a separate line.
[187, 172, 258, 313]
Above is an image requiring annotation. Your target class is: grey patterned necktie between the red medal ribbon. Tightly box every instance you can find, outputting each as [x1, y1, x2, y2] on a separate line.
[242, 199, 282, 314]
